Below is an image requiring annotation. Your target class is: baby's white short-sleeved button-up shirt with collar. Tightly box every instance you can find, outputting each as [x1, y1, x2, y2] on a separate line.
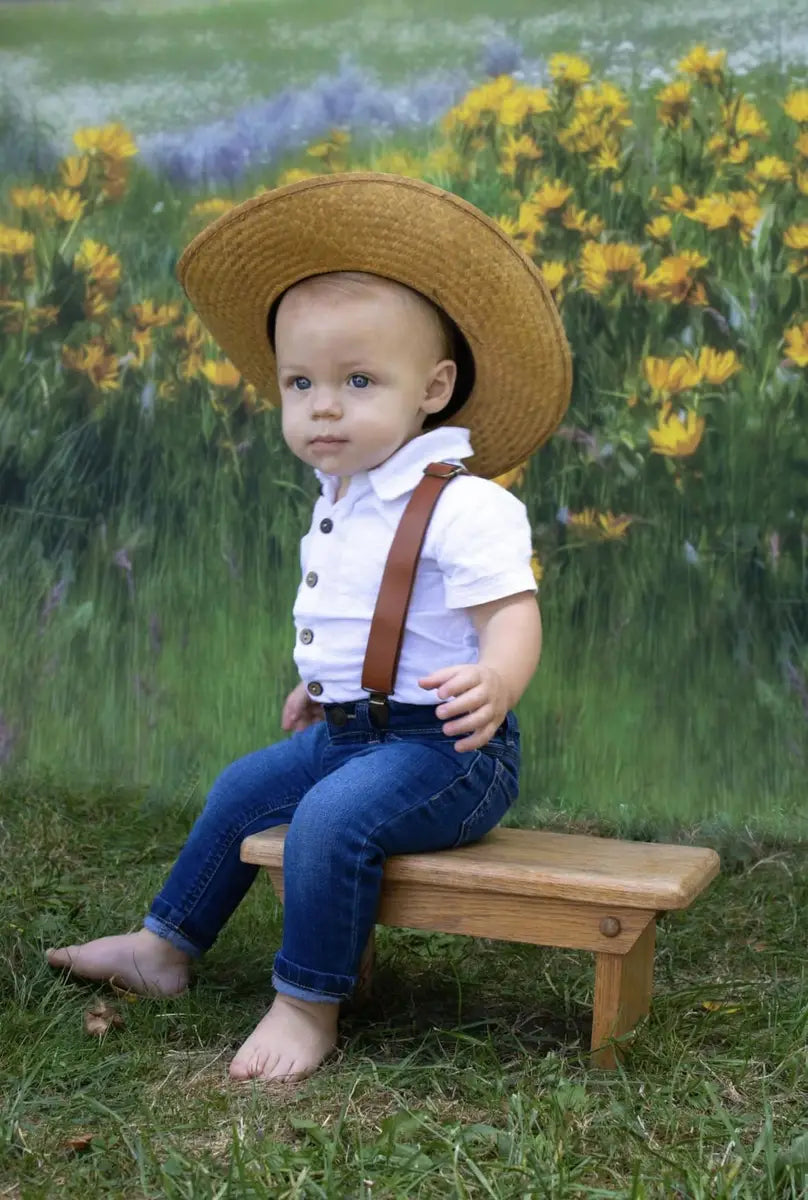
[293, 425, 538, 704]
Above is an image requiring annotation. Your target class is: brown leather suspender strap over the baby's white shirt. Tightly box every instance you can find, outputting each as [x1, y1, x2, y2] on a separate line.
[361, 462, 468, 726]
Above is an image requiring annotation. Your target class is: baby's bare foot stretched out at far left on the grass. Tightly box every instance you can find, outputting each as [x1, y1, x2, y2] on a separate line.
[46, 929, 190, 996]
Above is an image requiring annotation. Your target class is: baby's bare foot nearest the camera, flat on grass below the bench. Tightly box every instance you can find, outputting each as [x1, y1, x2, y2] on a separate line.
[231, 992, 340, 1080]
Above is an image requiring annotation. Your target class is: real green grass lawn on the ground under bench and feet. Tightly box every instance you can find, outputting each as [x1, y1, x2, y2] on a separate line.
[0, 787, 808, 1200]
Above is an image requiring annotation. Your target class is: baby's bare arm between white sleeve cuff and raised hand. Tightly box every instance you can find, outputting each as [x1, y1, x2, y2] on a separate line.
[467, 592, 541, 708]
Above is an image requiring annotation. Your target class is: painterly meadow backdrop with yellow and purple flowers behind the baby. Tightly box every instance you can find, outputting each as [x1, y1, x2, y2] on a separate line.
[0, 0, 808, 838]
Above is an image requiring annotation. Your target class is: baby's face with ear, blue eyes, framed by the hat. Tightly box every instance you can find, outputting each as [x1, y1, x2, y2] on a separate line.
[275, 275, 456, 479]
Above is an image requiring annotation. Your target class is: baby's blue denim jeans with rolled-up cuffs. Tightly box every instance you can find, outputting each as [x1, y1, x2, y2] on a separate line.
[144, 700, 520, 1002]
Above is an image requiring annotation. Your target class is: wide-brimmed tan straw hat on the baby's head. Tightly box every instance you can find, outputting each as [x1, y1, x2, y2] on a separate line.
[176, 172, 571, 479]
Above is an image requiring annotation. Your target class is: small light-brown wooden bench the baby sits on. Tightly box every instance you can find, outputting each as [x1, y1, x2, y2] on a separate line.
[241, 826, 719, 1068]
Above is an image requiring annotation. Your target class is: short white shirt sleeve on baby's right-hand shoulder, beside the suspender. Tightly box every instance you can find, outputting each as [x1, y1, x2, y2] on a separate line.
[431, 475, 538, 608]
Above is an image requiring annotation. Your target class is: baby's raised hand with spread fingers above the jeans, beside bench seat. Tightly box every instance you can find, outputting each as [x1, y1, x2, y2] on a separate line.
[418, 662, 510, 754]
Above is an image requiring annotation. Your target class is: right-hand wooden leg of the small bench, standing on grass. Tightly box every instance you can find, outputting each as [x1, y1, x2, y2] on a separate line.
[592, 920, 657, 1068]
